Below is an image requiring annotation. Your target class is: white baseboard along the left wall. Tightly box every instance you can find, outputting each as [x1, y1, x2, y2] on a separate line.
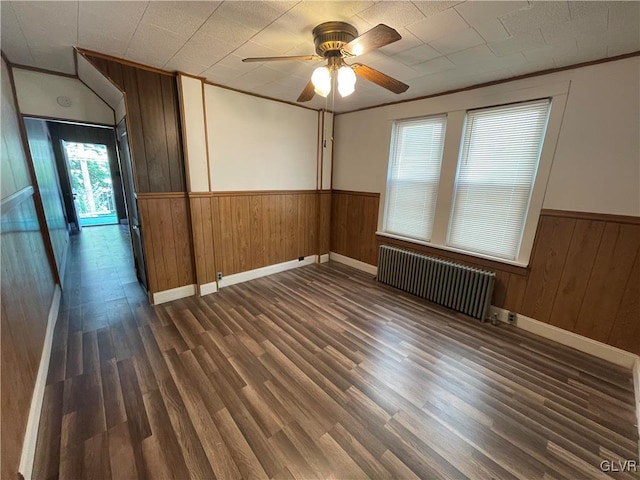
[18, 285, 61, 480]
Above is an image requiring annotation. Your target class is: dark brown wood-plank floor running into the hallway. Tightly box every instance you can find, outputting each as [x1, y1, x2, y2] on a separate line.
[34, 226, 638, 480]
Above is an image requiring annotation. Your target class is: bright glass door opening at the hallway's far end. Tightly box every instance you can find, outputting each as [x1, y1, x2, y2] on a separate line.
[62, 140, 118, 227]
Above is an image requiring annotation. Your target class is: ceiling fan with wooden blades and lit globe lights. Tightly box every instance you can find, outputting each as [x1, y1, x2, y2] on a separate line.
[242, 22, 409, 102]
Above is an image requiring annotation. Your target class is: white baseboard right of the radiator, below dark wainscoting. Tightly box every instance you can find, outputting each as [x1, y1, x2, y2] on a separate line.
[491, 305, 640, 369]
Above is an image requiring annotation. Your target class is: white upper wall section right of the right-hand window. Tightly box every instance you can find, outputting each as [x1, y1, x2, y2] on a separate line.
[544, 57, 640, 216]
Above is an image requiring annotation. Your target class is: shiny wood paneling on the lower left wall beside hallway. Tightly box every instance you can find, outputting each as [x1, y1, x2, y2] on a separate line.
[0, 186, 55, 478]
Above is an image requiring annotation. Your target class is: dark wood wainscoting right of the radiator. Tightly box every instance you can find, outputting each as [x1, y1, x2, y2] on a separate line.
[520, 211, 640, 354]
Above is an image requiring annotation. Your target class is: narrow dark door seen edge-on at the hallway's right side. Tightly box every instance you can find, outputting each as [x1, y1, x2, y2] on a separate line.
[116, 119, 149, 290]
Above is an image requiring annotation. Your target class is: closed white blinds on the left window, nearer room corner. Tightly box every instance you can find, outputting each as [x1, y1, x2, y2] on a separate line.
[384, 115, 446, 241]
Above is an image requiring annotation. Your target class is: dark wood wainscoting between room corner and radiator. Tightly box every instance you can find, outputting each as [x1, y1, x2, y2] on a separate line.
[331, 190, 380, 265]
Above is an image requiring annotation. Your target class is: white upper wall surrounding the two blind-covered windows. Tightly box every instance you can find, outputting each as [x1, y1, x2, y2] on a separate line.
[333, 57, 640, 216]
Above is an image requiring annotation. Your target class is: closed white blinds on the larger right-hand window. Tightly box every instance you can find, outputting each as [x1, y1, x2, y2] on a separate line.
[447, 99, 550, 260]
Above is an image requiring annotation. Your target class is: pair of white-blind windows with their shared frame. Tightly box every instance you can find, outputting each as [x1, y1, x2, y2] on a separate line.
[381, 95, 552, 266]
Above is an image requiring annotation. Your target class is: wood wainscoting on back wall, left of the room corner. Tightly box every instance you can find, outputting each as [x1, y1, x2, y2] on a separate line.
[189, 190, 320, 285]
